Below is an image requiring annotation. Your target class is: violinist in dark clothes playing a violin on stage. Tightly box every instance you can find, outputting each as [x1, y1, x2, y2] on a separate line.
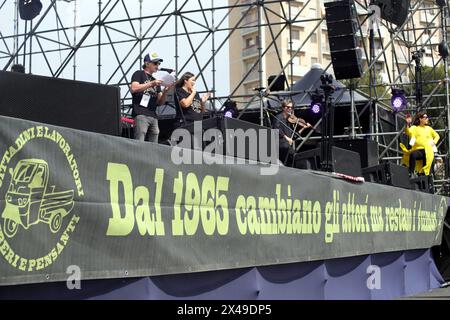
[273, 99, 312, 164]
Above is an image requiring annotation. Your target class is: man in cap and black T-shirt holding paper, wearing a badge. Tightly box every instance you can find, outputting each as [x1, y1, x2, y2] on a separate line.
[131, 52, 173, 143]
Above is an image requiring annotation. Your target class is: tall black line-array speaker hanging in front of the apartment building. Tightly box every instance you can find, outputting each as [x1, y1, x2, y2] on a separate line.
[325, 0, 362, 80]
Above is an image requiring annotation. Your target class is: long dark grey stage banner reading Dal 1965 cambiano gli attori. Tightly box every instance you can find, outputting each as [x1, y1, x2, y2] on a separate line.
[0, 117, 448, 285]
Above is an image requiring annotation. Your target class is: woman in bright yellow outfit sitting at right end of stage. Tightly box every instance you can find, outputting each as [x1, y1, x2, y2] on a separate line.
[400, 112, 440, 176]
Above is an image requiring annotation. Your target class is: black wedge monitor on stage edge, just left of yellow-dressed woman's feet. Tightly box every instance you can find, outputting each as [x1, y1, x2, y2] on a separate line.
[363, 162, 411, 189]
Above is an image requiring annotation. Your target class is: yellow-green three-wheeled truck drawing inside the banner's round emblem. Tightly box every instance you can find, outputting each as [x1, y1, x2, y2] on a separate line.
[1, 159, 74, 238]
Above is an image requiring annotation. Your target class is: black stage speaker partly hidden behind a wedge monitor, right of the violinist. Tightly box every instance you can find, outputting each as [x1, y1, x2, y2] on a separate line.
[333, 139, 378, 168]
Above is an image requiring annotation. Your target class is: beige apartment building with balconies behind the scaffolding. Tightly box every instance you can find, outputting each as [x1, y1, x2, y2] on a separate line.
[229, 0, 442, 99]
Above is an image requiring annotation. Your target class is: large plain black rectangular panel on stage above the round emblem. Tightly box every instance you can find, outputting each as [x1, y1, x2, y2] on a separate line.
[0, 71, 121, 136]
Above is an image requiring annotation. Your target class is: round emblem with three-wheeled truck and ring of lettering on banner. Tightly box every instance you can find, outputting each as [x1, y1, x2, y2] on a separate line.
[0, 126, 84, 272]
